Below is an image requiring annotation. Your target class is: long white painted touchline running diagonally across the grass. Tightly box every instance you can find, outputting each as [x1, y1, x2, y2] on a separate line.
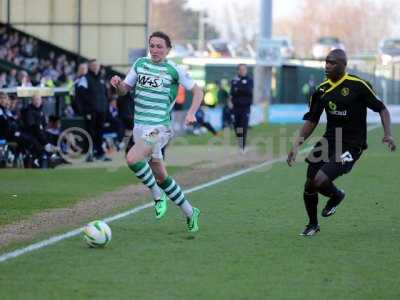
[0, 124, 380, 263]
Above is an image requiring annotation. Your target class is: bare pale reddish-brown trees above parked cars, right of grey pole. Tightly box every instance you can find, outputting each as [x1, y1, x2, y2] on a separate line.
[274, 0, 399, 56]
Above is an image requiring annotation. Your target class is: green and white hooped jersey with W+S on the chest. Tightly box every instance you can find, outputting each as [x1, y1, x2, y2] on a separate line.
[124, 57, 195, 126]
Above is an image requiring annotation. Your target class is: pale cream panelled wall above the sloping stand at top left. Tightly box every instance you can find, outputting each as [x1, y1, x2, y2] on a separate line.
[0, 0, 147, 69]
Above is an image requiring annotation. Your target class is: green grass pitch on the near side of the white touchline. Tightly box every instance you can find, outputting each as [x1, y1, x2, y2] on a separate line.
[0, 127, 400, 300]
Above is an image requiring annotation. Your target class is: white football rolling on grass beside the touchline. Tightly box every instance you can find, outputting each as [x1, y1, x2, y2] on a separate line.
[83, 220, 111, 248]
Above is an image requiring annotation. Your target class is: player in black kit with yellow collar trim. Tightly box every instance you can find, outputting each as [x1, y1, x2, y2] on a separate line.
[287, 49, 396, 236]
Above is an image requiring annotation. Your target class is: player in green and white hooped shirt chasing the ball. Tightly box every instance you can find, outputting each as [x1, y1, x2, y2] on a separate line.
[110, 31, 203, 232]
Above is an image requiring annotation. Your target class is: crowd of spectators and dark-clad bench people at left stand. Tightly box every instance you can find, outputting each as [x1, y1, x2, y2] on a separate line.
[0, 27, 132, 168]
